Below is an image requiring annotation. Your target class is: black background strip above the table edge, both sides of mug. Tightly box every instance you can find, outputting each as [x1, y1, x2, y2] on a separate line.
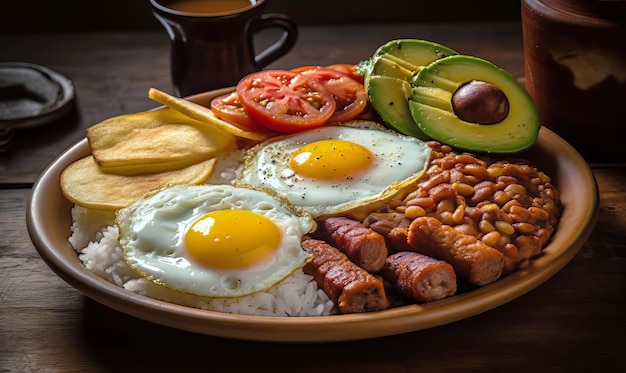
[0, 0, 521, 34]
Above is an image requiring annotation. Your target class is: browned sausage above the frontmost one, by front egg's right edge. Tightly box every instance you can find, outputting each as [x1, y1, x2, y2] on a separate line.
[313, 217, 388, 273]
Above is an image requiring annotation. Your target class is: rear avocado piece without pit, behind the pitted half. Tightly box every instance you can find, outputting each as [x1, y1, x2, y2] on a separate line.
[364, 39, 457, 140]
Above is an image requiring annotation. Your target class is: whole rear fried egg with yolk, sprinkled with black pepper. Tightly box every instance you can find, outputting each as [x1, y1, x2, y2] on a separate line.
[235, 121, 430, 217]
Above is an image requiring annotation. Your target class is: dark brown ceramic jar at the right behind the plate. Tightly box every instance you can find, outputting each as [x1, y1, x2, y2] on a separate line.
[522, 0, 626, 162]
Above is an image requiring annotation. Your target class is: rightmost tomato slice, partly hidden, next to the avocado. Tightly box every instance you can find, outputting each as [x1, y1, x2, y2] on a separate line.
[301, 67, 367, 122]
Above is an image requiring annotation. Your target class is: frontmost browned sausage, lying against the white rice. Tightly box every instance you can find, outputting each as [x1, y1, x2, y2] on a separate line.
[302, 237, 390, 313]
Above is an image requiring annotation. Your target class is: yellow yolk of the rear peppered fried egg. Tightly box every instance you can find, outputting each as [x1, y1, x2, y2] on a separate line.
[289, 140, 374, 179]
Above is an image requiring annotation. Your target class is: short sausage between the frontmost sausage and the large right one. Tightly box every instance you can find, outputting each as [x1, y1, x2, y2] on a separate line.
[381, 251, 457, 302]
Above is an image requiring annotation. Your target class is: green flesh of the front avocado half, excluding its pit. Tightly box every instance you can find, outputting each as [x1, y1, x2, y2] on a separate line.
[408, 55, 541, 153]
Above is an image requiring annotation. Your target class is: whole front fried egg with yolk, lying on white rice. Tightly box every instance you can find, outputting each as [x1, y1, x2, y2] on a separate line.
[116, 185, 315, 297]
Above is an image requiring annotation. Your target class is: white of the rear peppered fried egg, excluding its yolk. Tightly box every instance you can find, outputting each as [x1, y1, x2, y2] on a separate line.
[234, 121, 430, 217]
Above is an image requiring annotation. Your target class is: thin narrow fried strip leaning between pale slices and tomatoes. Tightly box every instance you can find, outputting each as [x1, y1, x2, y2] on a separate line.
[148, 88, 276, 141]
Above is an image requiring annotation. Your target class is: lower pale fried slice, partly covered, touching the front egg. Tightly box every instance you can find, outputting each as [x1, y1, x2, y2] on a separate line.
[61, 155, 217, 210]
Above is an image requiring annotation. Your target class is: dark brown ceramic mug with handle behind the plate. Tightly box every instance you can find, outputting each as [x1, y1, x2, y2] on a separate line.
[150, 0, 298, 97]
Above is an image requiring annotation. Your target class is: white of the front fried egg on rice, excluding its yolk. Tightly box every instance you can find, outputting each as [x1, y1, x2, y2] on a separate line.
[116, 185, 314, 297]
